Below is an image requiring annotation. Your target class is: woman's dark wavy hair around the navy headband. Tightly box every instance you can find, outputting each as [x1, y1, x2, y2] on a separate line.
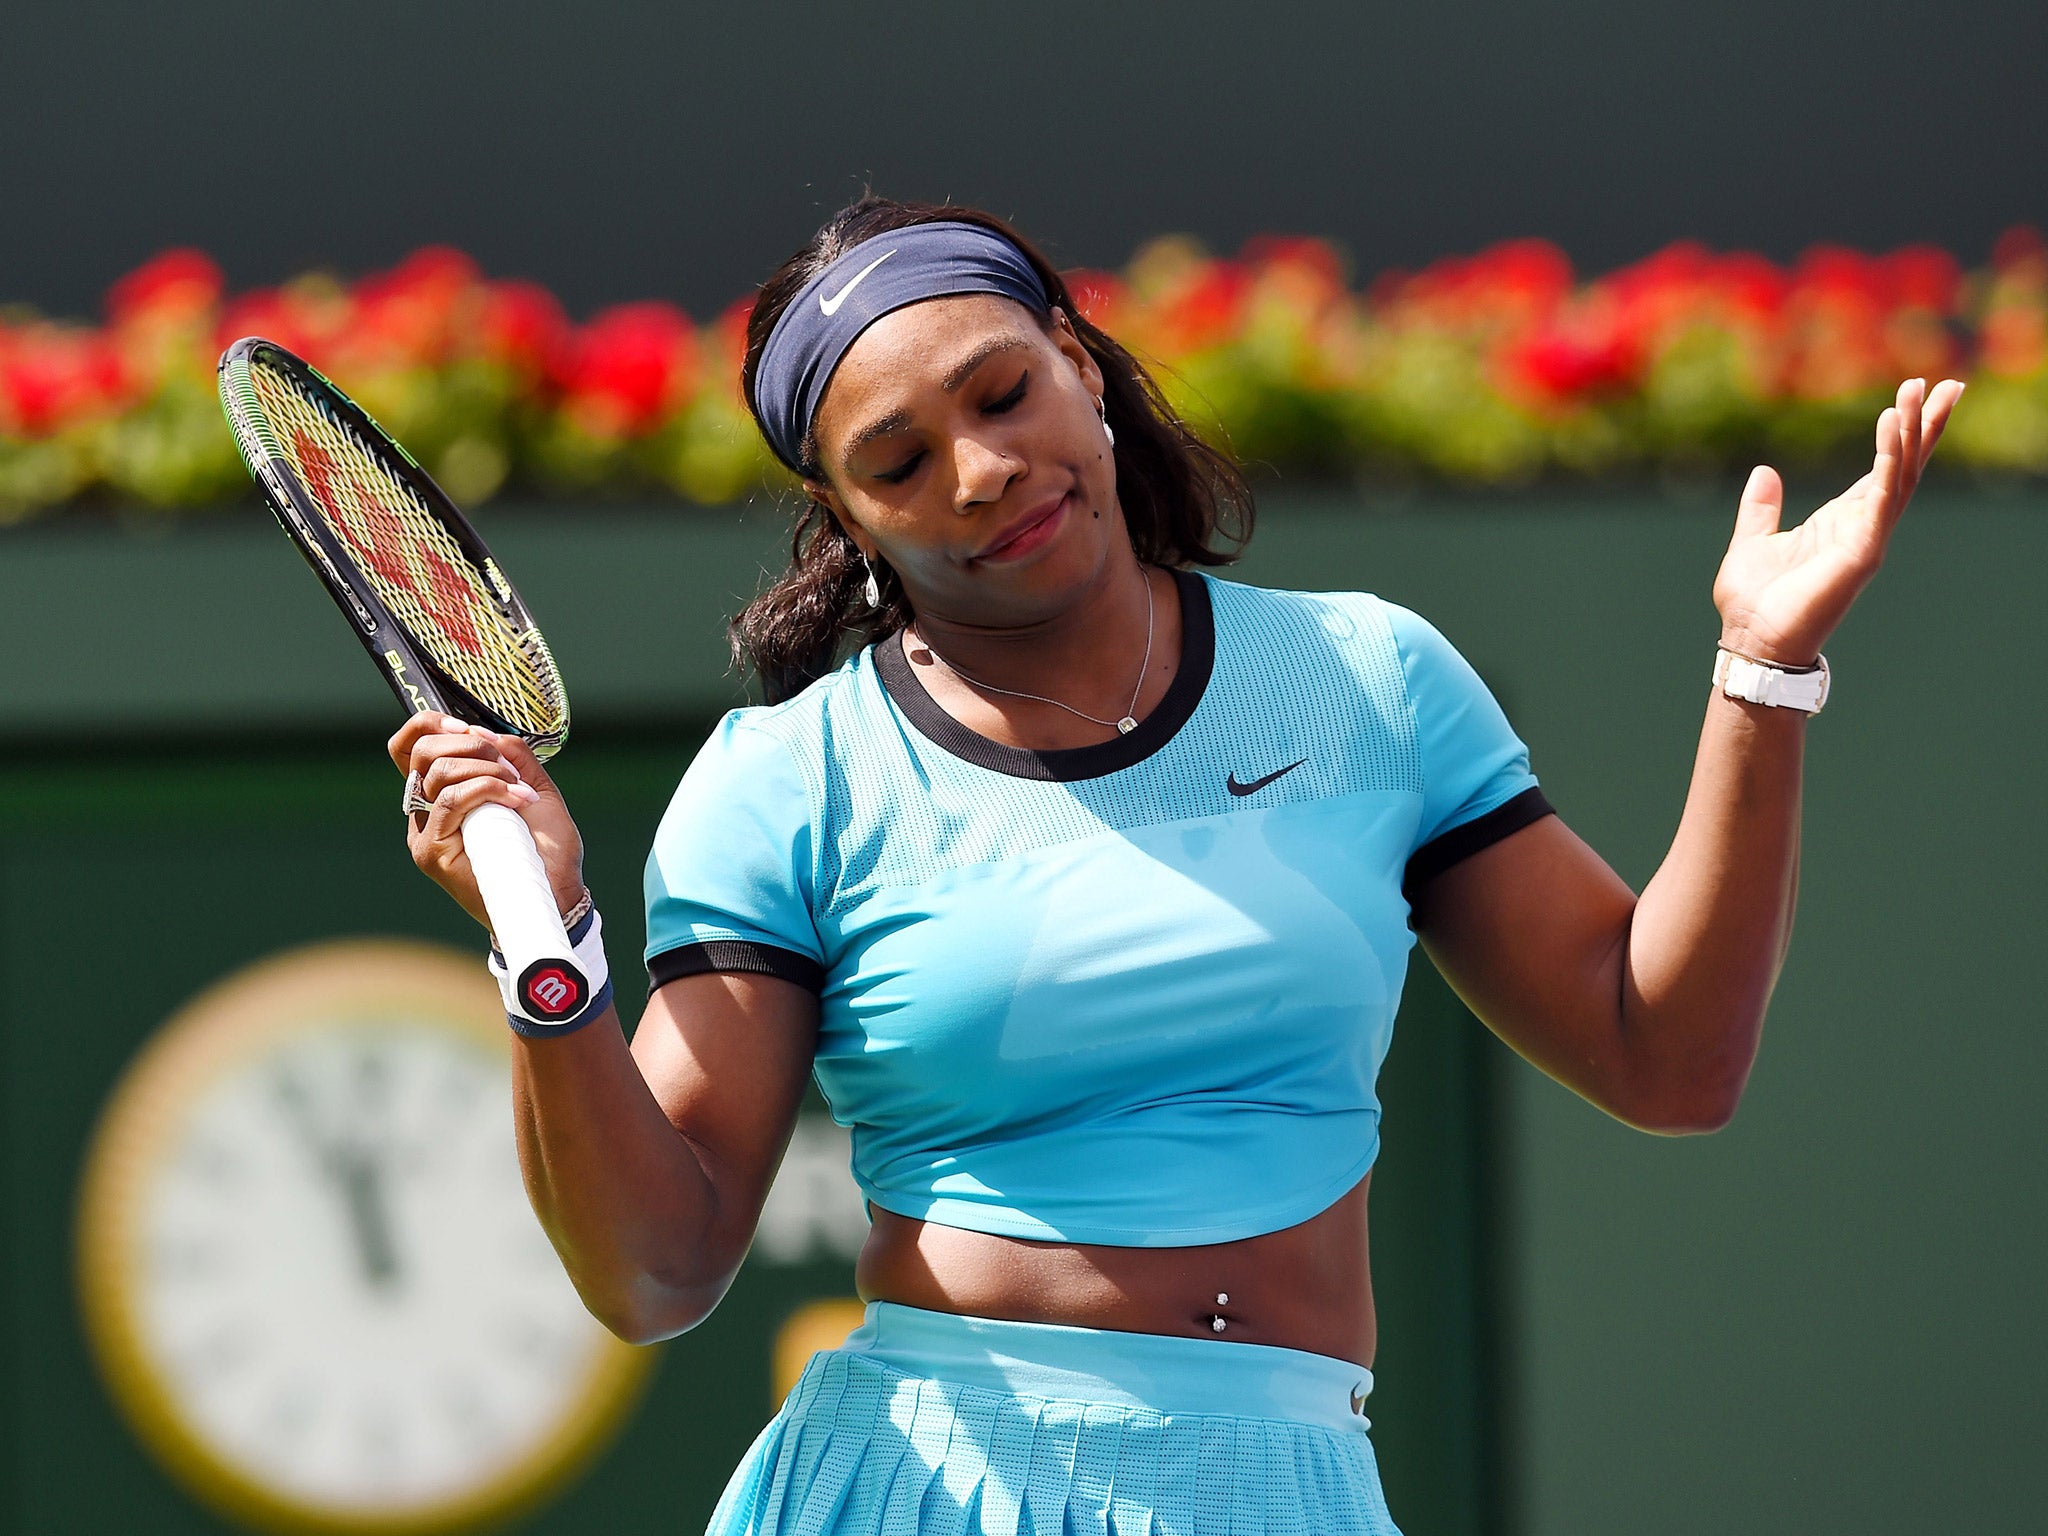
[727, 197, 1253, 702]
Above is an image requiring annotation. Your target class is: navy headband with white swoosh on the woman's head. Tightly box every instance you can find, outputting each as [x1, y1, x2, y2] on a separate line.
[754, 221, 1053, 473]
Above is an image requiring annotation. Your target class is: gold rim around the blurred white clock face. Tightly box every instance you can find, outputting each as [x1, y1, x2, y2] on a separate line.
[76, 938, 655, 1536]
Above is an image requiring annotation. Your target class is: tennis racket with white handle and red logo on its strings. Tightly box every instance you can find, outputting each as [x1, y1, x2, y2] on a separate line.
[219, 336, 590, 1022]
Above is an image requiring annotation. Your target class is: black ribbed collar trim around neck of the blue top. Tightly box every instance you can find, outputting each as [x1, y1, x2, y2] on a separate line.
[874, 571, 1217, 784]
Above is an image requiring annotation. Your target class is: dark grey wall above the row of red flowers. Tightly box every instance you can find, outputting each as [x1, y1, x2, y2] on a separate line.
[0, 0, 2048, 313]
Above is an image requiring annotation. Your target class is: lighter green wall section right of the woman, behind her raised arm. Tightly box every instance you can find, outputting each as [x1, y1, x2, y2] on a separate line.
[1220, 487, 2048, 1536]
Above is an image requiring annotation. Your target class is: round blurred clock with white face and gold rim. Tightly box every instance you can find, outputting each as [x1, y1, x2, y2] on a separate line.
[78, 940, 651, 1534]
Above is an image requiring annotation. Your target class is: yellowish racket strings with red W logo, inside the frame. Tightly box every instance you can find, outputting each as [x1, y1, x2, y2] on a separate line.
[250, 367, 565, 735]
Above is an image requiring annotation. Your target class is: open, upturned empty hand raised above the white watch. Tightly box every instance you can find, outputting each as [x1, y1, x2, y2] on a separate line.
[1714, 379, 1962, 666]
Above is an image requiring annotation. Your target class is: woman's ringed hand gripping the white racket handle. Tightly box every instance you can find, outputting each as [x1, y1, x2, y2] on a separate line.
[389, 711, 584, 928]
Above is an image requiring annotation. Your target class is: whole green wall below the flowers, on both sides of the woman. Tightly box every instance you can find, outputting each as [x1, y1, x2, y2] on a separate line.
[0, 492, 2048, 1536]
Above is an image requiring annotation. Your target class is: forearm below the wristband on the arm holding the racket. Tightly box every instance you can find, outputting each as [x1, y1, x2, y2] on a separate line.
[512, 1010, 737, 1341]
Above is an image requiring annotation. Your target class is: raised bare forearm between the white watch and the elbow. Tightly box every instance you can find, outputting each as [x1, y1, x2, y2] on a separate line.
[1614, 688, 1806, 1130]
